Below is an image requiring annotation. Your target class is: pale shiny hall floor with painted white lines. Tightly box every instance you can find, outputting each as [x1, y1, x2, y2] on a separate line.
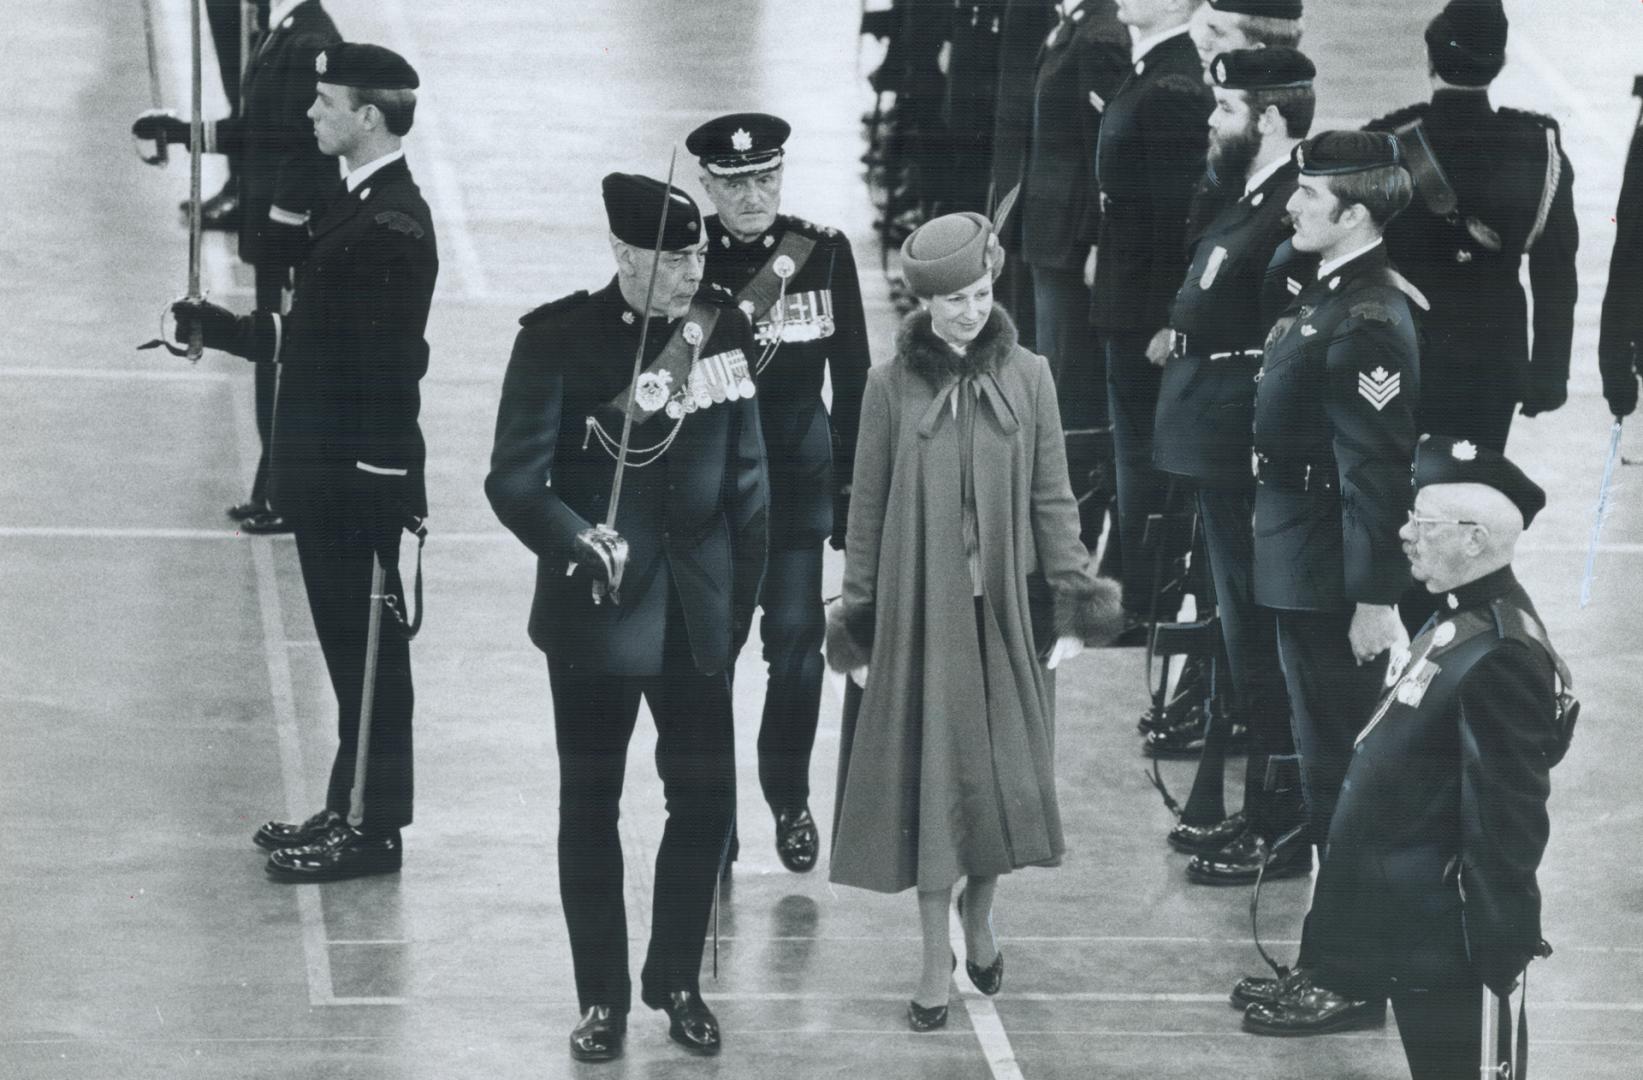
[0, 0, 1643, 1080]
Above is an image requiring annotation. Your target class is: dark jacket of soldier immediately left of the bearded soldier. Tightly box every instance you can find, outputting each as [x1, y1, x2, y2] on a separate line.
[1091, 35, 1214, 332]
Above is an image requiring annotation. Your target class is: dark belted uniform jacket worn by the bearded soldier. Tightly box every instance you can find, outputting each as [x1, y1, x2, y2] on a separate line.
[1153, 163, 1298, 488]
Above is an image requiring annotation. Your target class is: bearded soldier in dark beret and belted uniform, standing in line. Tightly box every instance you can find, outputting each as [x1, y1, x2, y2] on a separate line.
[1153, 46, 1316, 884]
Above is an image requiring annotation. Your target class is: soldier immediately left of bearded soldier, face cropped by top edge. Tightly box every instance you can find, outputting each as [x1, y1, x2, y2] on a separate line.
[1091, 0, 1213, 631]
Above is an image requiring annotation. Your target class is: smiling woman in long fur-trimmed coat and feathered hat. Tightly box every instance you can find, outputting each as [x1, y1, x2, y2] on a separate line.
[828, 214, 1121, 1031]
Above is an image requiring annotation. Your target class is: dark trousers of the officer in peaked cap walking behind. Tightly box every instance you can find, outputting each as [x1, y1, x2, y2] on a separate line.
[759, 542, 826, 812]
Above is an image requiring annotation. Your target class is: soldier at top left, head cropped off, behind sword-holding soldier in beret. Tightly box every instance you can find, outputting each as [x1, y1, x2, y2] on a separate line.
[131, 0, 342, 534]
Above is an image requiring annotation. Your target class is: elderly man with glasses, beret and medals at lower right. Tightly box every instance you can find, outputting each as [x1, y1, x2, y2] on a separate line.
[1245, 436, 1576, 1080]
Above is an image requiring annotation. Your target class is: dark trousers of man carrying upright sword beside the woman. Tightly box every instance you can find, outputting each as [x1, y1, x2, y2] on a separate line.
[547, 597, 736, 1013]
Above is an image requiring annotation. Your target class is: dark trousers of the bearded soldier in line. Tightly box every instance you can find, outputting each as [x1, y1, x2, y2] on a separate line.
[1198, 485, 1295, 828]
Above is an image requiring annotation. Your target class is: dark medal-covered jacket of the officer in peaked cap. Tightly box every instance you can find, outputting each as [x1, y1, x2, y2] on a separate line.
[705, 214, 872, 549]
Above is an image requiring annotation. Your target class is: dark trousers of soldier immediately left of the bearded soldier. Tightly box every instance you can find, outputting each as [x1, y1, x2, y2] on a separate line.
[1099, 330, 1191, 621]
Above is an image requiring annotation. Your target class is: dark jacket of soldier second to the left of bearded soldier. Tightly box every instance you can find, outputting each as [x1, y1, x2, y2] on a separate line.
[1019, 0, 1130, 270]
